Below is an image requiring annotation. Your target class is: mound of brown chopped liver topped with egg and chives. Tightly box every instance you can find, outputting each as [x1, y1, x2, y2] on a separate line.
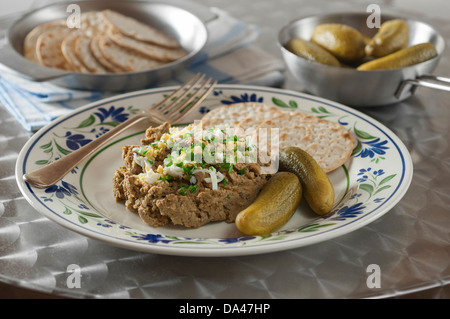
[113, 123, 269, 228]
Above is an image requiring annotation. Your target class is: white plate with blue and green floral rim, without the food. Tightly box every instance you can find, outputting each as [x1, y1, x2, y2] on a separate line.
[16, 85, 413, 256]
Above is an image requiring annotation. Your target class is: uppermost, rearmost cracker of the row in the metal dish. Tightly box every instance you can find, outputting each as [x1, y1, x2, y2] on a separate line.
[101, 10, 180, 48]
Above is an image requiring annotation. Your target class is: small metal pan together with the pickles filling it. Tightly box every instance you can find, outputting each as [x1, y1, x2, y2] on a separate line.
[278, 13, 450, 107]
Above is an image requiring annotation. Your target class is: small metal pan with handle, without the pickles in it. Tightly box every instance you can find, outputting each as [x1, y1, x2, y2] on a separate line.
[278, 13, 450, 107]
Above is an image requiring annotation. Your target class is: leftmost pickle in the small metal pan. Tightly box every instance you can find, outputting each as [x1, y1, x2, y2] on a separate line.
[284, 38, 340, 66]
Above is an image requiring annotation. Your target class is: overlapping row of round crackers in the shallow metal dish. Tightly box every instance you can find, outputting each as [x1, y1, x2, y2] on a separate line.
[23, 10, 186, 73]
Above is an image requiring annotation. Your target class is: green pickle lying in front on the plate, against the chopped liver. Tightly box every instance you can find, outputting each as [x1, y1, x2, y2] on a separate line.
[235, 172, 302, 235]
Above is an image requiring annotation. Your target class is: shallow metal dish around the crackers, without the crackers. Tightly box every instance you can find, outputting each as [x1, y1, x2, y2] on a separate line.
[0, 0, 208, 91]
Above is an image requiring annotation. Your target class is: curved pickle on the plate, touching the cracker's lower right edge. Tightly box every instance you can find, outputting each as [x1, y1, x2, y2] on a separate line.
[279, 147, 334, 215]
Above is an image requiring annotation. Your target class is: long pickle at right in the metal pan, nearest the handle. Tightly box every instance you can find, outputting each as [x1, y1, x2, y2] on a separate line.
[356, 43, 438, 71]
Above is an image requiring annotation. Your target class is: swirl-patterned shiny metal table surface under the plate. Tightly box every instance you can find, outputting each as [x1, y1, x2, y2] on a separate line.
[0, 0, 450, 298]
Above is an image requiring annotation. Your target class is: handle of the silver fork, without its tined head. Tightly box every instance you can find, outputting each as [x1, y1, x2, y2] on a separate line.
[23, 114, 161, 188]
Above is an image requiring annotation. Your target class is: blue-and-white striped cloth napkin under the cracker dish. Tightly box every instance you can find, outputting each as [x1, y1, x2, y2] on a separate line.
[0, 8, 284, 131]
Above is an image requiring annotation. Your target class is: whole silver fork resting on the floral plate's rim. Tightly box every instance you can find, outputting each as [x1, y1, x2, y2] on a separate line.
[23, 73, 217, 188]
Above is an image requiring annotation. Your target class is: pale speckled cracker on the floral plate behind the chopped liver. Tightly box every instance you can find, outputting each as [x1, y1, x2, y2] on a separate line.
[202, 102, 354, 173]
